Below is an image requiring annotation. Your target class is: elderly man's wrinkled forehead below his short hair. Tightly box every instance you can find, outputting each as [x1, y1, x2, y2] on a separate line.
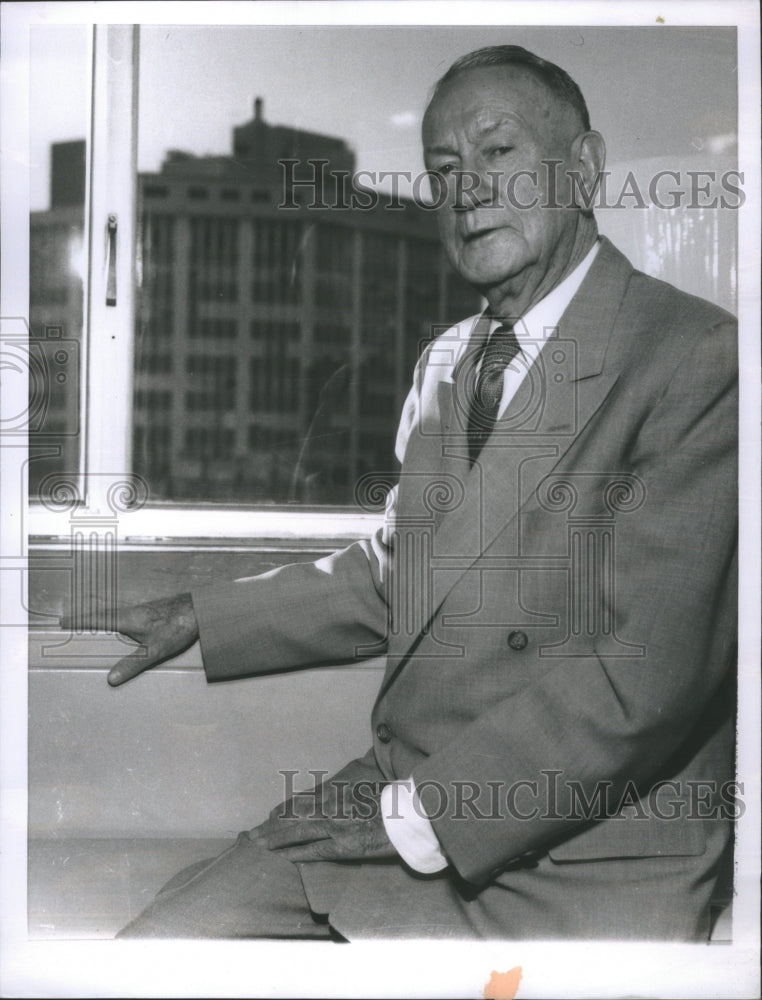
[422, 66, 576, 148]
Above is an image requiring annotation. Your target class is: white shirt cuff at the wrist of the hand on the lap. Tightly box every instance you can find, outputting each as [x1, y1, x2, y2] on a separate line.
[381, 778, 448, 875]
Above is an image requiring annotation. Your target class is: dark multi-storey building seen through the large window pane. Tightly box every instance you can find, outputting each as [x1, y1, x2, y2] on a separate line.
[135, 100, 478, 503]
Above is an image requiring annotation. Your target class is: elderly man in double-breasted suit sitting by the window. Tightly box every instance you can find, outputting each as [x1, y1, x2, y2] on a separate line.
[75, 46, 736, 940]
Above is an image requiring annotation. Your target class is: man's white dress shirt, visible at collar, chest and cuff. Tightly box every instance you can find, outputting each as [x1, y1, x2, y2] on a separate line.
[381, 242, 598, 875]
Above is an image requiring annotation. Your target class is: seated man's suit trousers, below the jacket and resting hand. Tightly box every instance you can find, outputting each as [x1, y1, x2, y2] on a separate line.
[117, 831, 724, 941]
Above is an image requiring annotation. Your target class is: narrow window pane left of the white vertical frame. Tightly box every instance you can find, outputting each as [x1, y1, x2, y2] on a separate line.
[29, 25, 90, 497]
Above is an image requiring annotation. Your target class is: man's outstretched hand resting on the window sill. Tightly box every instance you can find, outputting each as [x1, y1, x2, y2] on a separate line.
[60, 594, 198, 687]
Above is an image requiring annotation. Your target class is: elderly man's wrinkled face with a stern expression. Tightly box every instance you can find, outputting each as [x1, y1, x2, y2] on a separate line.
[423, 66, 582, 292]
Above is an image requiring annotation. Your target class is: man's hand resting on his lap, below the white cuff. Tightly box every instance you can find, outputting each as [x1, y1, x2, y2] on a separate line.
[249, 810, 398, 861]
